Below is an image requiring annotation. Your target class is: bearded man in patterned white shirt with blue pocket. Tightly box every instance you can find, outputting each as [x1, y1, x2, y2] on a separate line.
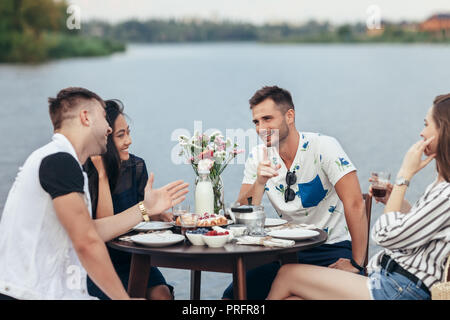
[223, 86, 368, 299]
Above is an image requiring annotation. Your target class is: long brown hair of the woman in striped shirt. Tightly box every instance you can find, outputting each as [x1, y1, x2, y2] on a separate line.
[433, 94, 450, 182]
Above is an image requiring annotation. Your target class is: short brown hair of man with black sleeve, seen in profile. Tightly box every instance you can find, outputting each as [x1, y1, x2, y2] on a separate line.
[48, 87, 105, 130]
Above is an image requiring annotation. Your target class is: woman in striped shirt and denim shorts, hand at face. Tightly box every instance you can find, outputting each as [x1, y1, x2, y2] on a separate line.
[268, 94, 450, 300]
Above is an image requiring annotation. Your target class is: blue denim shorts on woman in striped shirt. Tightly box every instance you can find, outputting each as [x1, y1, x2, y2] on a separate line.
[367, 268, 431, 300]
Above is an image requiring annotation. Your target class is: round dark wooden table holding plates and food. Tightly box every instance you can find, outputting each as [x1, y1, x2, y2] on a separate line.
[107, 229, 327, 300]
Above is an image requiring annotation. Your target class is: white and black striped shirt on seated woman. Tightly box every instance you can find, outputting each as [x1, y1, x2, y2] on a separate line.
[368, 181, 450, 288]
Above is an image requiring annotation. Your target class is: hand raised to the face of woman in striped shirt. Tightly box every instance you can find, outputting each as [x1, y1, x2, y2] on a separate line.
[398, 136, 436, 180]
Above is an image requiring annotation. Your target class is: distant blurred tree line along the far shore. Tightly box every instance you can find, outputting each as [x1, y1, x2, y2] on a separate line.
[83, 19, 450, 43]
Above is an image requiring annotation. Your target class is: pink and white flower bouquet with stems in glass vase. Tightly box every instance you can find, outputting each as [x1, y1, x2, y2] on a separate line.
[178, 131, 244, 214]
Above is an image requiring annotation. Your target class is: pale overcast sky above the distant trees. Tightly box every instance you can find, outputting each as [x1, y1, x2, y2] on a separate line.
[68, 0, 450, 24]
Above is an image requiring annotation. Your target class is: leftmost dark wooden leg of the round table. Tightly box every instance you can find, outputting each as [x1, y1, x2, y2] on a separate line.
[128, 253, 151, 298]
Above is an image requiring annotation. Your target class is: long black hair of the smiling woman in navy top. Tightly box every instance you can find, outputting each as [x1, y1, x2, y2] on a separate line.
[84, 99, 125, 217]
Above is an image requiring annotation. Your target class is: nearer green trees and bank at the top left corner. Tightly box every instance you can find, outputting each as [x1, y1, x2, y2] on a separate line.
[0, 0, 125, 63]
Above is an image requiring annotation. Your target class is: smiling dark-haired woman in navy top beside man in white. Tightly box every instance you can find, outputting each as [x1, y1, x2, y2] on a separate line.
[85, 100, 173, 300]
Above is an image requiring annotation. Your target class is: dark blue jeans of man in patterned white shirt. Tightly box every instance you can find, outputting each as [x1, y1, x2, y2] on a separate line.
[222, 241, 362, 300]
